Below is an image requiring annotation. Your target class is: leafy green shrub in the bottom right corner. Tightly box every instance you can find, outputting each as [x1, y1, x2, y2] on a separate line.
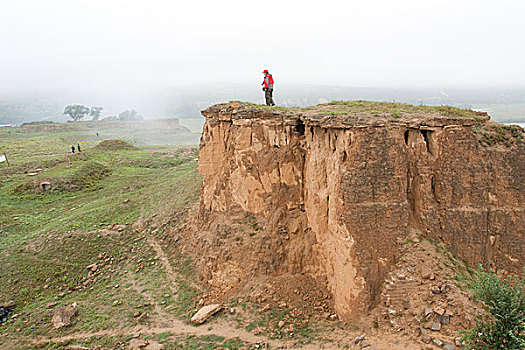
[463, 266, 525, 350]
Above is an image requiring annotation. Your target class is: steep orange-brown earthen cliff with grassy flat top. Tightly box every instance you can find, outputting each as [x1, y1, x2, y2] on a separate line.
[190, 101, 525, 318]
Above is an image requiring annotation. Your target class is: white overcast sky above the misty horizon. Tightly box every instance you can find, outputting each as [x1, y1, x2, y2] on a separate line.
[0, 0, 525, 90]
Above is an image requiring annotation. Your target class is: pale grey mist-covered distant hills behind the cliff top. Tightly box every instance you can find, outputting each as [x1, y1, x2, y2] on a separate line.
[0, 84, 525, 124]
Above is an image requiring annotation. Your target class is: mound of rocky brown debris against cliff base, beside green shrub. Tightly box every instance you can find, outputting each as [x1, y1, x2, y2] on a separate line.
[371, 232, 479, 348]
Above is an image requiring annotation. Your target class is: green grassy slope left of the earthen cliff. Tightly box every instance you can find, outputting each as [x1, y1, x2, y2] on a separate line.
[0, 125, 231, 349]
